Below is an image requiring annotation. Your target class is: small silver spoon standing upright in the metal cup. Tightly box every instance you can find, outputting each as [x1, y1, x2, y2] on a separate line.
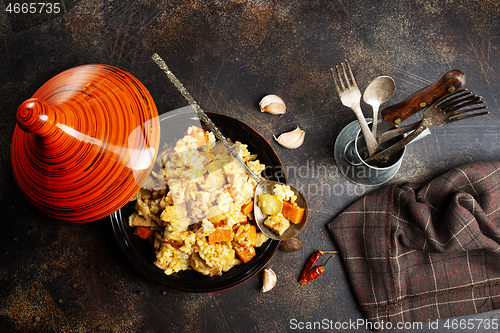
[363, 75, 396, 137]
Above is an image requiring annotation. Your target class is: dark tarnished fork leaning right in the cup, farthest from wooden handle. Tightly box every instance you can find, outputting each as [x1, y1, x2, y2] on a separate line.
[365, 89, 488, 166]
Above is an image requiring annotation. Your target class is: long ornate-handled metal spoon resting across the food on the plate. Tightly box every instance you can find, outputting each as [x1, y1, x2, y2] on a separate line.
[151, 53, 308, 240]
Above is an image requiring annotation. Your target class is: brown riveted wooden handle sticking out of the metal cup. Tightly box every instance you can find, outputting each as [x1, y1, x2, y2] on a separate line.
[381, 69, 465, 125]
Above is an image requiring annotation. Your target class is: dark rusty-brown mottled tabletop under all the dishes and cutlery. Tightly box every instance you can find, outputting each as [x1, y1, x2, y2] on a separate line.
[0, 0, 500, 332]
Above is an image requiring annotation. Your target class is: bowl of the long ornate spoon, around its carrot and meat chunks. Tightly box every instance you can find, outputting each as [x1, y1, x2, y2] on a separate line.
[253, 180, 308, 240]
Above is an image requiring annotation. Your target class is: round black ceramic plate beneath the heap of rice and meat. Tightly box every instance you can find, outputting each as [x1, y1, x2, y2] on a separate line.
[110, 108, 287, 293]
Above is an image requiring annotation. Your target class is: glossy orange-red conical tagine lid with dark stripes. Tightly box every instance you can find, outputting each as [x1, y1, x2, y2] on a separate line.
[11, 65, 160, 222]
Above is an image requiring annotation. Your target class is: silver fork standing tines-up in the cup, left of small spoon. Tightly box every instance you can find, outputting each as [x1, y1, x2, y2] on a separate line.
[330, 60, 380, 156]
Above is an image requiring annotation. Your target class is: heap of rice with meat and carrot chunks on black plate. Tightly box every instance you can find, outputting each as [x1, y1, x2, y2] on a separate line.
[129, 126, 268, 276]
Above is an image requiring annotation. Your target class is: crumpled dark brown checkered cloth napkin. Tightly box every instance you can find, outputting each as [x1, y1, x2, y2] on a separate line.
[329, 161, 500, 327]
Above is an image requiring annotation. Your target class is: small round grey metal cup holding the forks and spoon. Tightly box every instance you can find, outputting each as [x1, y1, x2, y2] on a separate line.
[334, 118, 406, 186]
